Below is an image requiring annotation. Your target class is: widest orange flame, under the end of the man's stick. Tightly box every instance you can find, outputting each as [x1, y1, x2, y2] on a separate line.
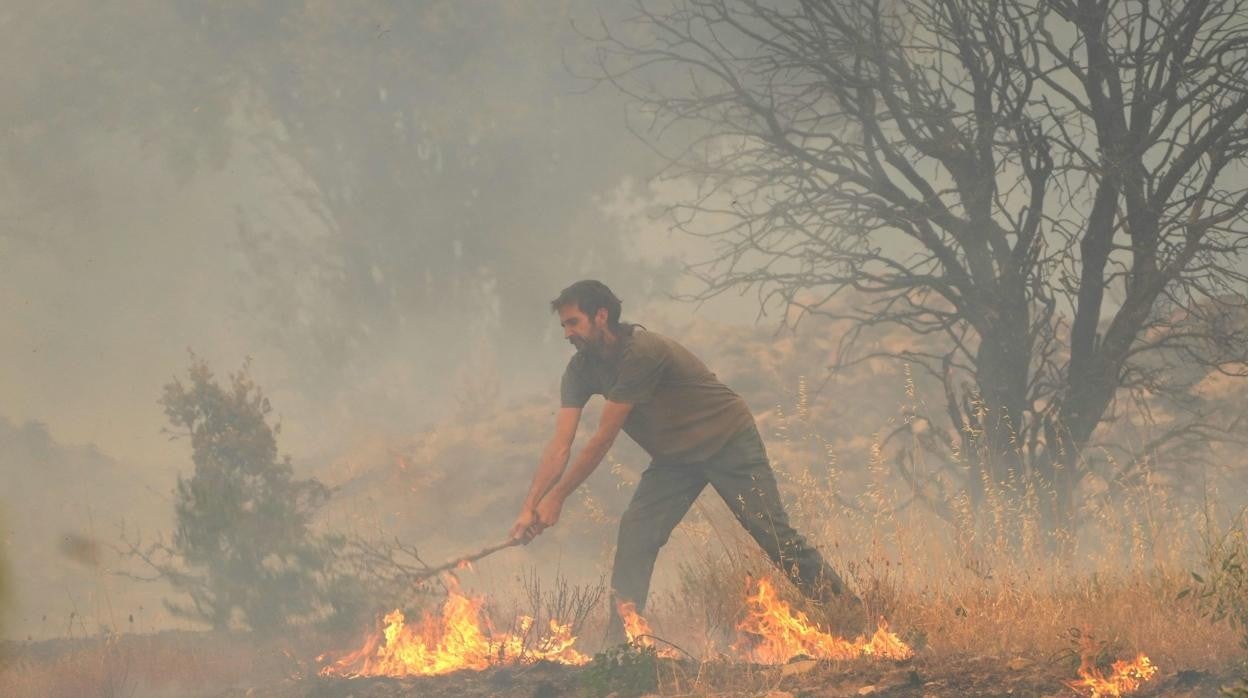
[321, 578, 589, 677]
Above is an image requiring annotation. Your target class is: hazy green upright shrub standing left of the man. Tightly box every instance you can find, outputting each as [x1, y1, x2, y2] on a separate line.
[156, 357, 333, 629]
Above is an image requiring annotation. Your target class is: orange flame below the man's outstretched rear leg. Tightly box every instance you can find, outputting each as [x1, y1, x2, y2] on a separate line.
[734, 579, 915, 664]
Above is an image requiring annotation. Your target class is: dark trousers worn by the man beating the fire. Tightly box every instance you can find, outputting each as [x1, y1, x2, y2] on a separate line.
[607, 425, 844, 644]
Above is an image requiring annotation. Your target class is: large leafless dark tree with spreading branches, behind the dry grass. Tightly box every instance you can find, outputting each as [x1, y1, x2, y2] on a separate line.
[587, 0, 1248, 541]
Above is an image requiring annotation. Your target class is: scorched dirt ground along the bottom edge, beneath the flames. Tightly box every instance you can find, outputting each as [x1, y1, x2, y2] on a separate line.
[7, 632, 1248, 698]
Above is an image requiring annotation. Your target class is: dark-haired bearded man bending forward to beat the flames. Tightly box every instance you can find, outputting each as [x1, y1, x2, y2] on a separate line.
[512, 280, 861, 644]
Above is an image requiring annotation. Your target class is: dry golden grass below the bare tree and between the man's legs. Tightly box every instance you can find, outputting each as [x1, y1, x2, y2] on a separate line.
[589, 377, 1248, 693]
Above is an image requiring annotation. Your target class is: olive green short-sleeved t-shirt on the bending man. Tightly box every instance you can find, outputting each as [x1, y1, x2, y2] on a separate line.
[560, 328, 754, 463]
